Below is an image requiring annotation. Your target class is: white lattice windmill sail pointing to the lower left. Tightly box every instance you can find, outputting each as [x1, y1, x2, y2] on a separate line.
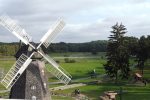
[1, 54, 33, 89]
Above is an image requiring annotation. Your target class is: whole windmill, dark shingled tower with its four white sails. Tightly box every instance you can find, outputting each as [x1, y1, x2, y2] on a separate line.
[0, 15, 71, 100]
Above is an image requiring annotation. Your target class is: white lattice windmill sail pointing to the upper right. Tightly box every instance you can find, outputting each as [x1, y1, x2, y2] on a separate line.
[40, 18, 65, 48]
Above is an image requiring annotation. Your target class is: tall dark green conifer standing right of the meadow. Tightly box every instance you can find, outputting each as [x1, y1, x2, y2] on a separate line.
[104, 23, 130, 83]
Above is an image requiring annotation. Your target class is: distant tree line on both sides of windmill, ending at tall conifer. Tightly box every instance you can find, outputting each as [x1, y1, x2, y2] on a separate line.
[0, 40, 108, 56]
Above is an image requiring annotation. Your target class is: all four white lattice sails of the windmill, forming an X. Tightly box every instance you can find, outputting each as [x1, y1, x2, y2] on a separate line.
[0, 15, 71, 89]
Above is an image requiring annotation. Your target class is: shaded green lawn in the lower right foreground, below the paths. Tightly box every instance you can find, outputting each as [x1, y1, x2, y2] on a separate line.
[53, 83, 150, 100]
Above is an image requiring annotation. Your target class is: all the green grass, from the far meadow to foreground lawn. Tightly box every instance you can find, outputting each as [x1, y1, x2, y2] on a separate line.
[0, 53, 150, 100]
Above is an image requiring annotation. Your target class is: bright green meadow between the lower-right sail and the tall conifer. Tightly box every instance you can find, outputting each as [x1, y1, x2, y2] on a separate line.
[60, 59, 105, 79]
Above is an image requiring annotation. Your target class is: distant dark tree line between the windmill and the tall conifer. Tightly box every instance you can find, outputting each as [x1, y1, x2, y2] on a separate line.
[43, 40, 108, 53]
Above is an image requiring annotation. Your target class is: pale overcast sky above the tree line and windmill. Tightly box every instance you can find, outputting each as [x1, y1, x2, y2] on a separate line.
[0, 0, 150, 43]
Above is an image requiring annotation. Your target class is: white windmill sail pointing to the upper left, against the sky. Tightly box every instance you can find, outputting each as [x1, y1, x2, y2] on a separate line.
[0, 15, 31, 45]
